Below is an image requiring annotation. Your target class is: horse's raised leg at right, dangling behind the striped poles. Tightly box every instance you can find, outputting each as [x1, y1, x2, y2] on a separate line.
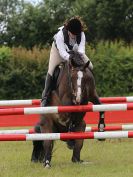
[91, 91, 105, 132]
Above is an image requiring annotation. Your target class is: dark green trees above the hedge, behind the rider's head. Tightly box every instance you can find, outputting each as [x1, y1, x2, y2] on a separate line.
[0, 0, 133, 49]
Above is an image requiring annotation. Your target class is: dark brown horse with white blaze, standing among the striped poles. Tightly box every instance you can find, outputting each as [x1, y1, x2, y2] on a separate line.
[31, 51, 105, 168]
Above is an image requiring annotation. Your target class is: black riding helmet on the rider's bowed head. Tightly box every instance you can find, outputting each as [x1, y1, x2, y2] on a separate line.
[66, 18, 82, 35]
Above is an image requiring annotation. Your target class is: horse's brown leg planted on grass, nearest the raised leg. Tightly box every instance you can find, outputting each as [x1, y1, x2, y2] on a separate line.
[72, 121, 86, 162]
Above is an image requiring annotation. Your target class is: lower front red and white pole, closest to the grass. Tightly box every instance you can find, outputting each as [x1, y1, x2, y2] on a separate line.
[0, 131, 133, 141]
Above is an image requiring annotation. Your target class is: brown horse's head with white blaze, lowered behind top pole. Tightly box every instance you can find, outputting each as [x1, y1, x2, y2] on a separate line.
[69, 51, 89, 104]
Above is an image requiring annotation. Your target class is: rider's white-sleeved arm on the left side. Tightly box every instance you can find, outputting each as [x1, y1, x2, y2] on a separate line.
[54, 30, 70, 60]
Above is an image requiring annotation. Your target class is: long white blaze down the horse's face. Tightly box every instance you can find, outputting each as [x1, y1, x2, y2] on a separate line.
[76, 71, 83, 103]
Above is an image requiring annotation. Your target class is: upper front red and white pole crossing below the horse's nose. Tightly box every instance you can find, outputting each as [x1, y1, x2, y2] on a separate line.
[0, 103, 133, 115]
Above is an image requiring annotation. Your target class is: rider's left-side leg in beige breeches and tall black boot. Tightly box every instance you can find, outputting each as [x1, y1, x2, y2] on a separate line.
[41, 42, 62, 106]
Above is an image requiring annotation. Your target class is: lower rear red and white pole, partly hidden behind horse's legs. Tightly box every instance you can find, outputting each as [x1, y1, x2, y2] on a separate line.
[0, 125, 133, 134]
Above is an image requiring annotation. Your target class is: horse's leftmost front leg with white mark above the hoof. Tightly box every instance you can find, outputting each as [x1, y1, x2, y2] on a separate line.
[40, 118, 54, 168]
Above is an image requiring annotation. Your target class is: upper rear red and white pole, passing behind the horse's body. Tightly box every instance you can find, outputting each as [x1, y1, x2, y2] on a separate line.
[0, 96, 133, 106]
